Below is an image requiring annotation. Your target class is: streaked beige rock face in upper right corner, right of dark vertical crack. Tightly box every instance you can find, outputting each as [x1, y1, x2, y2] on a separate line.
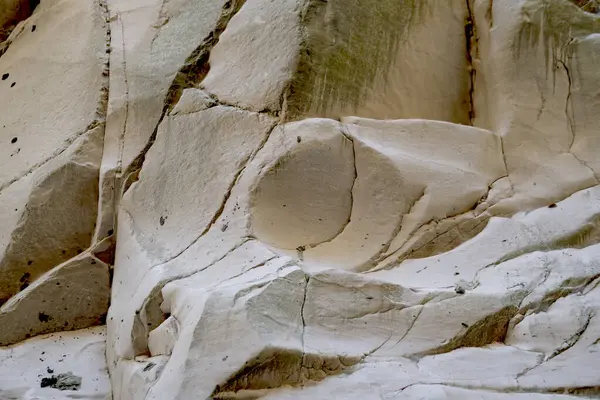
[473, 0, 600, 216]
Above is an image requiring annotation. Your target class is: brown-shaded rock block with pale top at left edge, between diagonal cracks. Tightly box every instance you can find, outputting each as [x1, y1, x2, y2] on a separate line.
[0, 126, 103, 300]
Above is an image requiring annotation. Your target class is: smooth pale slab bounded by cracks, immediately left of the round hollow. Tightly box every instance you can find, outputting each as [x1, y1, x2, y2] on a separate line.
[121, 106, 275, 262]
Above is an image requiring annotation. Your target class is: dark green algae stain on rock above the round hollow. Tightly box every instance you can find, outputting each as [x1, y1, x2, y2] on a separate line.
[286, 0, 432, 119]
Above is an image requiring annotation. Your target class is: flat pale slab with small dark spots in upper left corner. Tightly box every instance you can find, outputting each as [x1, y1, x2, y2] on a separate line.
[0, 0, 106, 190]
